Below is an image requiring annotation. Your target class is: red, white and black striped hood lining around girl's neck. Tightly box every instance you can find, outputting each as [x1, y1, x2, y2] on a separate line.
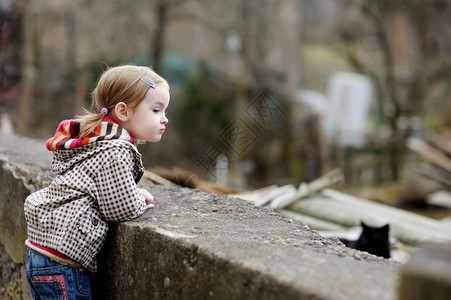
[46, 117, 135, 151]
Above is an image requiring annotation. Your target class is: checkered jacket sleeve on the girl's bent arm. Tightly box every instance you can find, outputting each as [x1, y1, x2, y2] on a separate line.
[95, 152, 146, 222]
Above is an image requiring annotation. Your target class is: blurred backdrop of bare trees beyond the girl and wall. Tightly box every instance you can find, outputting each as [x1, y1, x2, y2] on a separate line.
[0, 0, 451, 211]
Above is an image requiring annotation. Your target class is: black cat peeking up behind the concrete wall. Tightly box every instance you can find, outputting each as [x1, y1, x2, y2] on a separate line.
[340, 221, 390, 258]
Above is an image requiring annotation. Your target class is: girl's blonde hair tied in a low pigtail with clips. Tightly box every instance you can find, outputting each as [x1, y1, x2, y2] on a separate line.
[75, 65, 169, 137]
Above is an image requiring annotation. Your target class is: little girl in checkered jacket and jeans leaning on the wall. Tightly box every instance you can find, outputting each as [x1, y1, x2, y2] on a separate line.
[24, 65, 169, 299]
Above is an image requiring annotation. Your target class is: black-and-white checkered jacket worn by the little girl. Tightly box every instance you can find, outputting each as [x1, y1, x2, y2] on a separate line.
[24, 140, 146, 272]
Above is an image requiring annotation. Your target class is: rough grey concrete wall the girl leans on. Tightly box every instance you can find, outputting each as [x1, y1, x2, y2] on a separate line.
[0, 135, 400, 300]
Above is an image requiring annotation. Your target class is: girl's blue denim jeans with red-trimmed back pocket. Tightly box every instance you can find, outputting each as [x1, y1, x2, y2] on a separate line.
[25, 248, 92, 300]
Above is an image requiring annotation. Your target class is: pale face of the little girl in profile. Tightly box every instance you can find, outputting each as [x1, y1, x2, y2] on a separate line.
[121, 85, 170, 142]
